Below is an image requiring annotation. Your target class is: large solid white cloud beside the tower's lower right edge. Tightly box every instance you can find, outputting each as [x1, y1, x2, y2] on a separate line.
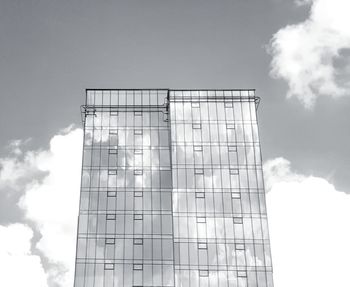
[264, 158, 350, 287]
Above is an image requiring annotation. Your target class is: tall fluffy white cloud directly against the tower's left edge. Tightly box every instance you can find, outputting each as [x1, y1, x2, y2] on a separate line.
[0, 127, 82, 286]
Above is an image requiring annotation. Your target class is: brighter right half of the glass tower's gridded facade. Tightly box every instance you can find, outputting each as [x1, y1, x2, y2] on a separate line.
[170, 91, 272, 287]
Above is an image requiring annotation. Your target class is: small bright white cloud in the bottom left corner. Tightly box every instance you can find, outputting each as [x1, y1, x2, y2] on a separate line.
[0, 224, 48, 287]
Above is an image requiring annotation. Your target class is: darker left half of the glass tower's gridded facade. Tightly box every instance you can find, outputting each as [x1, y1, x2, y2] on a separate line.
[75, 91, 174, 287]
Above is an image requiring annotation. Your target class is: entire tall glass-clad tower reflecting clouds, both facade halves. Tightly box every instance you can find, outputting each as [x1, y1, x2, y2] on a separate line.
[74, 90, 273, 287]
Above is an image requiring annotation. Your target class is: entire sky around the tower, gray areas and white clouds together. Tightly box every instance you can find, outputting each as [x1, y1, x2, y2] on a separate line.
[0, 0, 350, 287]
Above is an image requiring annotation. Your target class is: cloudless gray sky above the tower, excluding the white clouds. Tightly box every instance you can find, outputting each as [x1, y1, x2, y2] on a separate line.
[0, 0, 350, 192]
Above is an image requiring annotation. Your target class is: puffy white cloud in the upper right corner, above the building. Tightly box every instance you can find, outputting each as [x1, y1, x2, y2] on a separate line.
[269, 0, 350, 108]
